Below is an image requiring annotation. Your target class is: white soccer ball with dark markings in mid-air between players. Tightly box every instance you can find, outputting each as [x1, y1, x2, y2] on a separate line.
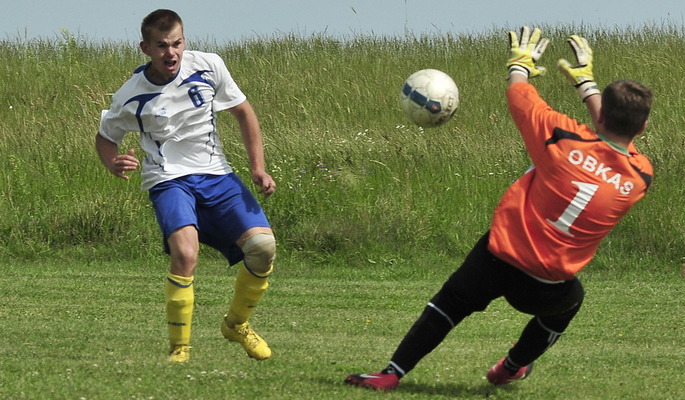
[400, 69, 459, 128]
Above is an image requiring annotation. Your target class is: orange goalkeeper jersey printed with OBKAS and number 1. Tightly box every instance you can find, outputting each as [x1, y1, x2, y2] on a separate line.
[488, 83, 653, 281]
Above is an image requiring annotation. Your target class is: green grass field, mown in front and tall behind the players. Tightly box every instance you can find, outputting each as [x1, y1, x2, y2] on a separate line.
[0, 26, 685, 399]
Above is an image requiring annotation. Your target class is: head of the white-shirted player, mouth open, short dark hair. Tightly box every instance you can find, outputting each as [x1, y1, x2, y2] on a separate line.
[140, 9, 185, 83]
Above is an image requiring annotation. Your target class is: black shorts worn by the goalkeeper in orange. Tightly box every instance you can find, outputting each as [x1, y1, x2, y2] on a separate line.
[431, 232, 585, 320]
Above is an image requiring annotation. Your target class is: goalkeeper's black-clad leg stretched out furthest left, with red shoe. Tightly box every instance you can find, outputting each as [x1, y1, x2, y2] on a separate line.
[345, 234, 502, 390]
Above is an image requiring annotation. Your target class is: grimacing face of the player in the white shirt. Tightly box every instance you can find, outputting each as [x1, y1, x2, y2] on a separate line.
[140, 24, 186, 83]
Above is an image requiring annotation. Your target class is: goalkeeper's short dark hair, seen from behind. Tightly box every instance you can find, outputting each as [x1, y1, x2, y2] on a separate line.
[602, 80, 653, 138]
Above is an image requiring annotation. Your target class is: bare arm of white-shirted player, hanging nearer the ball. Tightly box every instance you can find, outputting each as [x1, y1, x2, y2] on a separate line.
[228, 100, 276, 197]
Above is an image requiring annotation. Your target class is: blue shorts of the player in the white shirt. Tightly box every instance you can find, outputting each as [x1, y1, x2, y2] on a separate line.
[149, 173, 270, 265]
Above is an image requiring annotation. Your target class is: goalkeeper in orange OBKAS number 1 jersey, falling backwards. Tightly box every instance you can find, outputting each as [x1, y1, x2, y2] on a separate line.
[345, 27, 652, 391]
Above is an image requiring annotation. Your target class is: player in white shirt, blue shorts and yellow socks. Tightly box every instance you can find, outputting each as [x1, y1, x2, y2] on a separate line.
[95, 9, 276, 362]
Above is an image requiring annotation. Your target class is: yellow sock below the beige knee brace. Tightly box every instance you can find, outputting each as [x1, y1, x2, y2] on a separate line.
[225, 266, 273, 325]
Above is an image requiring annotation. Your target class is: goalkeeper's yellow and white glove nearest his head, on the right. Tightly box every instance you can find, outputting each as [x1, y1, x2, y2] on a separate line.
[557, 35, 600, 101]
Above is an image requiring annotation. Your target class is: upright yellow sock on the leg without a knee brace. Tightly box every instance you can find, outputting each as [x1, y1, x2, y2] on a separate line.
[165, 273, 195, 346]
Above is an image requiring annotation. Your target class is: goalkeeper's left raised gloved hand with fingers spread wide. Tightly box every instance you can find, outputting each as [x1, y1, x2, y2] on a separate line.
[507, 26, 549, 78]
